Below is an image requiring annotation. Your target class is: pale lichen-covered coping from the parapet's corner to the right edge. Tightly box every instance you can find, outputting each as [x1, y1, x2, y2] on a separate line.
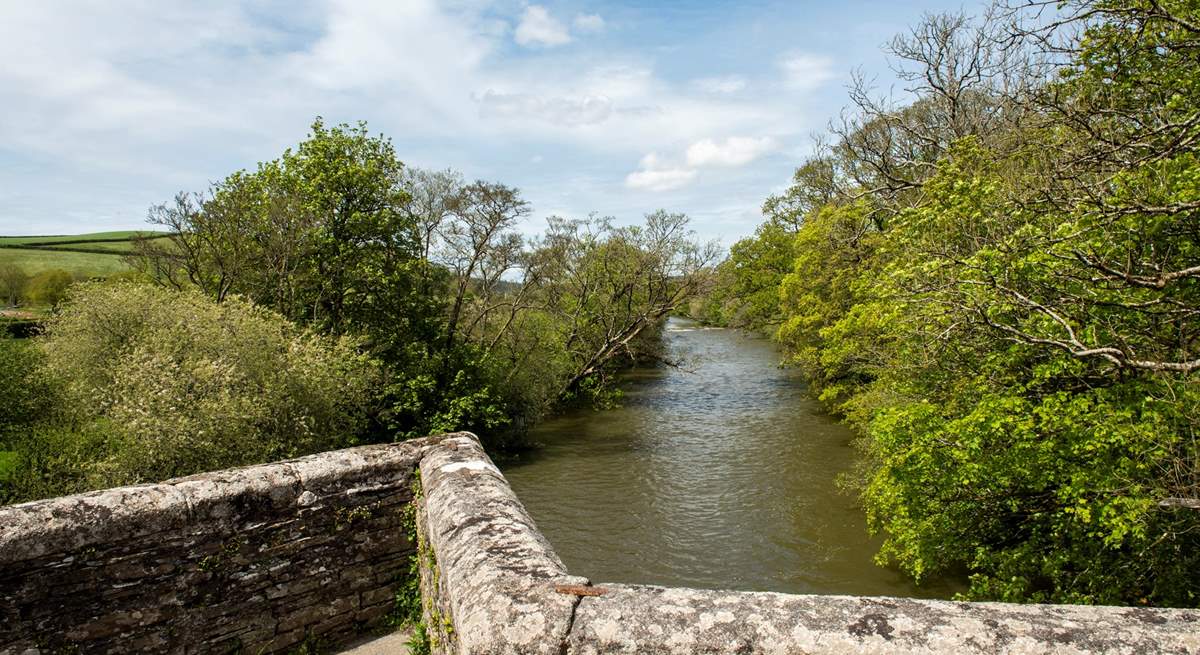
[420, 434, 1200, 655]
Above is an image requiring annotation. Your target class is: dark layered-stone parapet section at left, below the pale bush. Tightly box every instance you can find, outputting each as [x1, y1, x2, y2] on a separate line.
[0, 439, 436, 655]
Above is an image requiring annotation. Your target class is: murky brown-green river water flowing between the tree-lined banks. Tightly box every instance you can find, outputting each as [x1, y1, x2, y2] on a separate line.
[502, 319, 958, 597]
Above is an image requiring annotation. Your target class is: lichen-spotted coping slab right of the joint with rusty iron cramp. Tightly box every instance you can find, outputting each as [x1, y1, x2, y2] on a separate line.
[568, 584, 1200, 654]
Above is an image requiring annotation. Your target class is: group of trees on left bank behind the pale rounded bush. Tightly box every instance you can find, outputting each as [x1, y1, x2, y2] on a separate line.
[131, 119, 710, 445]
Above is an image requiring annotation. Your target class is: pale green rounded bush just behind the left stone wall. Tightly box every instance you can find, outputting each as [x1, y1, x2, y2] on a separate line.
[0, 283, 376, 498]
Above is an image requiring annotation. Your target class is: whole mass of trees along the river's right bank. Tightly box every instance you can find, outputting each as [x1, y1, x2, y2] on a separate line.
[691, 0, 1200, 606]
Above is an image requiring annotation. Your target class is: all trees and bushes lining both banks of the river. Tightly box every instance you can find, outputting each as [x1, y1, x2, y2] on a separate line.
[0, 0, 1200, 606]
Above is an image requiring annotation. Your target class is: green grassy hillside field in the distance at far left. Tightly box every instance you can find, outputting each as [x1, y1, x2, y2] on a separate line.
[0, 230, 174, 277]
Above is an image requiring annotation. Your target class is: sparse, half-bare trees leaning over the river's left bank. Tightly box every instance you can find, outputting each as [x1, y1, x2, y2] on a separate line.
[389, 207, 713, 445]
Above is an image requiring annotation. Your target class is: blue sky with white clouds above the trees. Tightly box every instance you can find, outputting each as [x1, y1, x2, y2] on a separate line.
[0, 0, 974, 245]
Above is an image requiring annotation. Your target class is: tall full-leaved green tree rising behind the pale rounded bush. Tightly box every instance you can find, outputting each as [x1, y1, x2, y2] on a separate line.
[132, 119, 431, 347]
